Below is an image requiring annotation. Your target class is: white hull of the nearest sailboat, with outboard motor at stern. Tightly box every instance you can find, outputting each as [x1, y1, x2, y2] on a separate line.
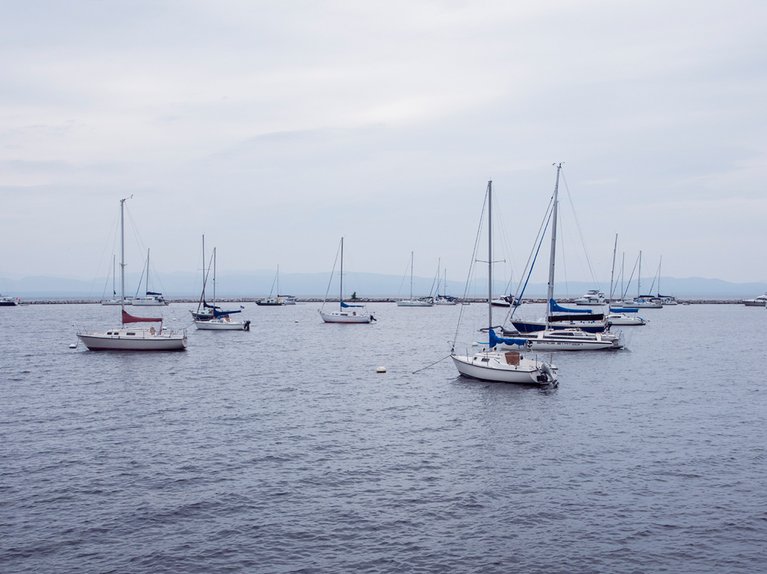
[451, 351, 557, 385]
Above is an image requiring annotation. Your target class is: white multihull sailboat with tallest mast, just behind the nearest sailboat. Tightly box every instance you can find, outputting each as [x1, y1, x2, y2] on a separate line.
[505, 163, 623, 351]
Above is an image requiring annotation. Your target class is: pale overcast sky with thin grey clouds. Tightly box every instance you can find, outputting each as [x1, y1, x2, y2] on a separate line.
[0, 0, 767, 288]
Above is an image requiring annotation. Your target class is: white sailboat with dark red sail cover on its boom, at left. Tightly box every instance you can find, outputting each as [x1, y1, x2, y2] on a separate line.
[77, 198, 187, 351]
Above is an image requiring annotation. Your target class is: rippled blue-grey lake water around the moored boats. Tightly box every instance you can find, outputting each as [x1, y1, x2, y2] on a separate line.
[0, 304, 767, 574]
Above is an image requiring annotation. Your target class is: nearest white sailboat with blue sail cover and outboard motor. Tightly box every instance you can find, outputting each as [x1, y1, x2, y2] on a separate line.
[450, 181, 558, 385]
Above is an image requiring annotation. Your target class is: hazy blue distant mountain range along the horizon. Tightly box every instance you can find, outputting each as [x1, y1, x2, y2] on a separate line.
[0, 271, 767, 300]
